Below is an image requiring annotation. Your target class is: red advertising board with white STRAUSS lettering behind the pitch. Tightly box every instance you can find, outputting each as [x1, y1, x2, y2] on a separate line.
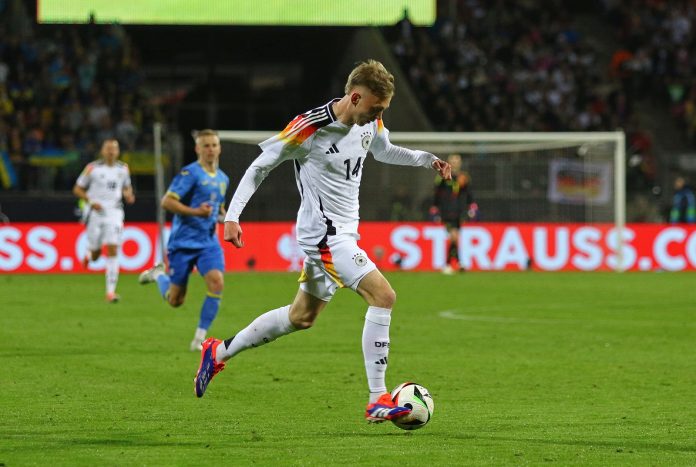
[0, 222, 696, 273]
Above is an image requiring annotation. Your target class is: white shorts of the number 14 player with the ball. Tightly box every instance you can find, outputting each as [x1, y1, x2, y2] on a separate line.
[299, 234, 377, 302]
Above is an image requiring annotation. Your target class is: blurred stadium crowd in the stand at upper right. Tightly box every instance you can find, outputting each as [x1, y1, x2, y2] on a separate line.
[387, 0, 696, 219]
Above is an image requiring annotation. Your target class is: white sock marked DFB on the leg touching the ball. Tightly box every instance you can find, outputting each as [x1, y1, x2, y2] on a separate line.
[362, 306, 391, 403]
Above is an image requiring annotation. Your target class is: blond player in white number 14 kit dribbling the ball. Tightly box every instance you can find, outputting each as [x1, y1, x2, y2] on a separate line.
[194, 60, 450, 422]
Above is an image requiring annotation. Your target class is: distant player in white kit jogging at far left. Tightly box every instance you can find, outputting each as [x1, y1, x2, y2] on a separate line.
[73, 139, 135, 303]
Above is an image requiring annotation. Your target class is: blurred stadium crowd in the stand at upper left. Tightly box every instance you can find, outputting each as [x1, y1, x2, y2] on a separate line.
[0, 0, 160, 189]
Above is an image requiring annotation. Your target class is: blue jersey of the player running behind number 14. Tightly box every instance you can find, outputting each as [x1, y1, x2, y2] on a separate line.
[167, 162, 230, 250]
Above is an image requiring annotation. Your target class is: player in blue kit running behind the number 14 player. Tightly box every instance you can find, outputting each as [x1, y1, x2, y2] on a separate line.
[139, 130, 229, 351]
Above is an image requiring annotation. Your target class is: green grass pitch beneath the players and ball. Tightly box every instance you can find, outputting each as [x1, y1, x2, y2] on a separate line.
[0, 273, 696, 467]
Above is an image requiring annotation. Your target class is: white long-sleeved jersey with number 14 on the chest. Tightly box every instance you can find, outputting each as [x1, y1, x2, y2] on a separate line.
[225, 99, 437, 246]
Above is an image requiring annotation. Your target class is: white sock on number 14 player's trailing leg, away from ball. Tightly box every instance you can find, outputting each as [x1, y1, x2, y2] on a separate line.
[216, 305, 296, 361]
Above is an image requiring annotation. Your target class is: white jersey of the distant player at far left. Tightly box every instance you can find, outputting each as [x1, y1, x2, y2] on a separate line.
[76, 161, 131, 223]
